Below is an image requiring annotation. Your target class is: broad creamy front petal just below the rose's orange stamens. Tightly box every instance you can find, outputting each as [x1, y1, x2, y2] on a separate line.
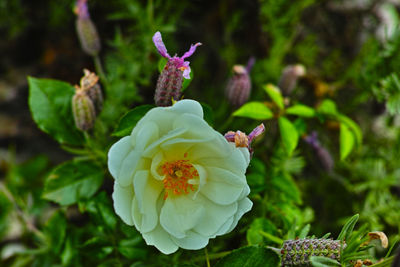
[160, 195, 205, 238]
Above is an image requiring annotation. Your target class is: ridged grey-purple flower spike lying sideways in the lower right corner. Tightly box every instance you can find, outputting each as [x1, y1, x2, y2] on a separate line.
[281, 239, 346, 266]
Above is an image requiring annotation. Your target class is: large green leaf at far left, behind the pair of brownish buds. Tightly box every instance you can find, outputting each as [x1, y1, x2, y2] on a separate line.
[28, 77, 83, 145]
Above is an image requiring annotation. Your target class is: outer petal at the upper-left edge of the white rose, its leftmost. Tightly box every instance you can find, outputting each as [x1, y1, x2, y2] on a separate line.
[108, 136, 132, 179]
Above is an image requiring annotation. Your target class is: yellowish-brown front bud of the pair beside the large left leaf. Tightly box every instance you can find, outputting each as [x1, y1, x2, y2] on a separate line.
[72, 87, 96, 131]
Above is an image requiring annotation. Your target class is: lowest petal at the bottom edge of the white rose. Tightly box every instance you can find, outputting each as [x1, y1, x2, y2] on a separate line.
[142, 224, 178, 254]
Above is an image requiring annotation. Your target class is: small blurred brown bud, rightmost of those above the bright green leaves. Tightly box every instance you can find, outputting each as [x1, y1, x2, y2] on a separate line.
[278, 64, 306, 95]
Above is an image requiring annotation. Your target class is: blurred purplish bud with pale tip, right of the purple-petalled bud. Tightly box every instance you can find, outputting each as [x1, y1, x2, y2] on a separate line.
[225, 65, 251, 107]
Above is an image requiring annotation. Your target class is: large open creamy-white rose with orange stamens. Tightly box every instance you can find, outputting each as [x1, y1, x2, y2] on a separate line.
[108, 100, 252, 254]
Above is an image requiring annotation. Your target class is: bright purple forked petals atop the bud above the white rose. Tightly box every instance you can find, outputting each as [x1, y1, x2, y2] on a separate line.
[153, 32, 201, 79]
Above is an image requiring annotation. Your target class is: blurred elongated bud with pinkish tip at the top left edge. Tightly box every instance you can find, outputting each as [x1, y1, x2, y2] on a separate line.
[75, 0, 101, 56]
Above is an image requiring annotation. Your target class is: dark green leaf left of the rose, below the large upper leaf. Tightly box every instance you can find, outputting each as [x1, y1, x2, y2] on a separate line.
[42, 161, 104, 205]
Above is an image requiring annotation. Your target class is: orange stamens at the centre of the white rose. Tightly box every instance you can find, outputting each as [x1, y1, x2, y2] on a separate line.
[161, 155, 199, 200]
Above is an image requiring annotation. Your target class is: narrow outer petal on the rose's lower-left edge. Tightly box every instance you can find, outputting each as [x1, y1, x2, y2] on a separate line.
[112, 181, 133, 225]
